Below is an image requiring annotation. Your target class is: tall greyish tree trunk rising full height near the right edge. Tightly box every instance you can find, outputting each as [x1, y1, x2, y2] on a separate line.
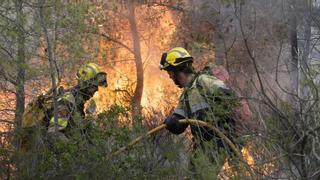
[289, 0, 311, 179]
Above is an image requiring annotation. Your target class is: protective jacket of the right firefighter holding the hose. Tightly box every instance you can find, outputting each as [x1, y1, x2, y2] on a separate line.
[167, 74, 236, 150]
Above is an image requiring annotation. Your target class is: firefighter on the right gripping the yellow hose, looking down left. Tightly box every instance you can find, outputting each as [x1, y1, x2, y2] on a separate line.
[160, 47, 235, 176]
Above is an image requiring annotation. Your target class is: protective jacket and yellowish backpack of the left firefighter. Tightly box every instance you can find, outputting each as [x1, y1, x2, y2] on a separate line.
[21, 86, 94, 150]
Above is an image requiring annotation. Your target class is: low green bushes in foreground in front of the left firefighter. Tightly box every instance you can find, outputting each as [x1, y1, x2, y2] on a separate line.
[17, 106, 190, 179]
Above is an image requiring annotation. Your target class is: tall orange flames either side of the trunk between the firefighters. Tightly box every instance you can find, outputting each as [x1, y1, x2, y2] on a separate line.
[94, 6, 179, 118]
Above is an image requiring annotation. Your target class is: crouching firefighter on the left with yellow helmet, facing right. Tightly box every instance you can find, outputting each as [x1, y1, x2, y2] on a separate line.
[22, 63, 107, 149]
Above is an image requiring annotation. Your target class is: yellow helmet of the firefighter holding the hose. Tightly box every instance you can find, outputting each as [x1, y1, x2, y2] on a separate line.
[160, 47, 193, 70]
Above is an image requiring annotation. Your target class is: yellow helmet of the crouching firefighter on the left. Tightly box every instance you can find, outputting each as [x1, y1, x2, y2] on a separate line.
[77, 63, 107, 87]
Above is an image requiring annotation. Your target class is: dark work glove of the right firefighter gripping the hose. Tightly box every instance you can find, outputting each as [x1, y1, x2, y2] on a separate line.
[164, 114, 189, 134]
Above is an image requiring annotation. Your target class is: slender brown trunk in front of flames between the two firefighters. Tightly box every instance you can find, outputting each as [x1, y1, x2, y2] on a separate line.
[127, 0, 143, 123]
